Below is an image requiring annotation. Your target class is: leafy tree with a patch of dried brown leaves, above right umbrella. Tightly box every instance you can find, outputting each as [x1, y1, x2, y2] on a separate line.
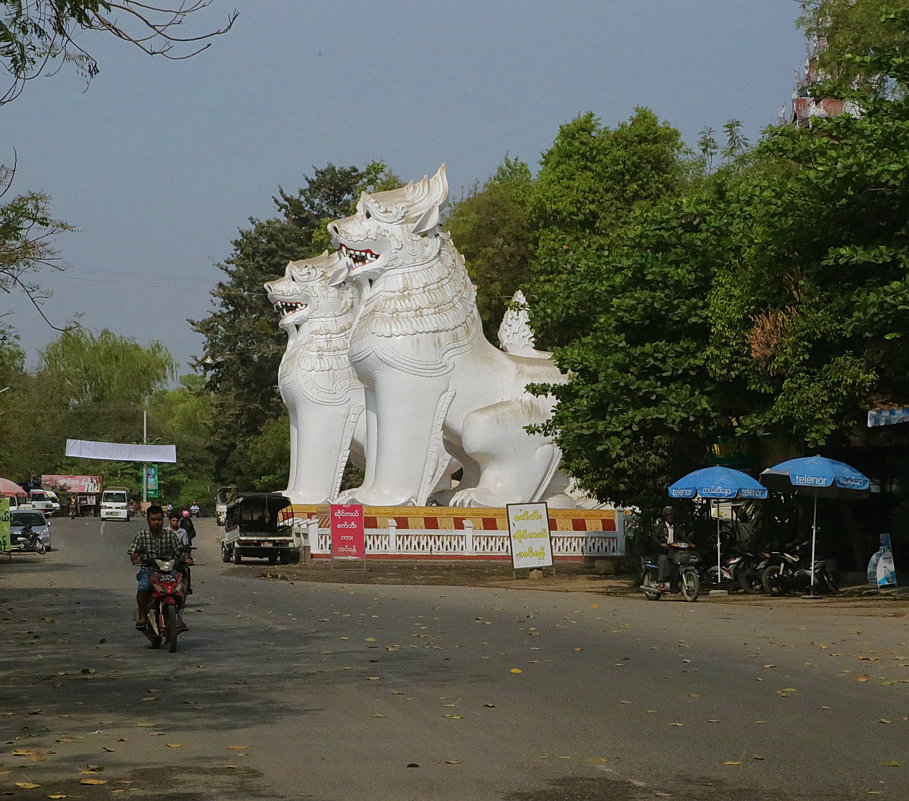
[711, 3, 909, 447]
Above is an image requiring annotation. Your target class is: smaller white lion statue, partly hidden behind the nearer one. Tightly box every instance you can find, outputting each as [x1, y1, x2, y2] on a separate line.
[265, 252, 366, 503]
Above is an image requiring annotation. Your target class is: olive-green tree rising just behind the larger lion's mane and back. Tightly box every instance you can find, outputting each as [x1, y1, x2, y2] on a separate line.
[445, 156, 534, 342]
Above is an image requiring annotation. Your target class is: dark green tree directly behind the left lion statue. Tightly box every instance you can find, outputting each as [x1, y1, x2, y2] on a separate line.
[190, 162, 400, 486]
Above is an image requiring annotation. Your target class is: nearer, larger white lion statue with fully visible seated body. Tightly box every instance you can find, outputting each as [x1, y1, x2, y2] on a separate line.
[328, 166, 566, 507]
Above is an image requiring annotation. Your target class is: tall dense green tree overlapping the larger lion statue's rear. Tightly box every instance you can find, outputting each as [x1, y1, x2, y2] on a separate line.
[516, 109, 717, 506]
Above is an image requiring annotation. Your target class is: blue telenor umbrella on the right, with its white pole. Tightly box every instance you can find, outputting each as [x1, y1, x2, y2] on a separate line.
[761, 454, 871, 594]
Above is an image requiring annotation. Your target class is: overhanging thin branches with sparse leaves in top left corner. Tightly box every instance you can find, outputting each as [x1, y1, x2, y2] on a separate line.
[0, 0, 237, 105]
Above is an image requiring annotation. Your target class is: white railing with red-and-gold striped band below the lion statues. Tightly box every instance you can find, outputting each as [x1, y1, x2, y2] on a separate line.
[293, 504, 625, 560]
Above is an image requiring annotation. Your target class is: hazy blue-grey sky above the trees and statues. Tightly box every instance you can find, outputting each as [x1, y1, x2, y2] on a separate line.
[0, 0, 805, 372]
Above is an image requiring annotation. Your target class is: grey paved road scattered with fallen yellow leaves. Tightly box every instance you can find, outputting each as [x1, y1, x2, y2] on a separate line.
[0, 519, 909, 801]
